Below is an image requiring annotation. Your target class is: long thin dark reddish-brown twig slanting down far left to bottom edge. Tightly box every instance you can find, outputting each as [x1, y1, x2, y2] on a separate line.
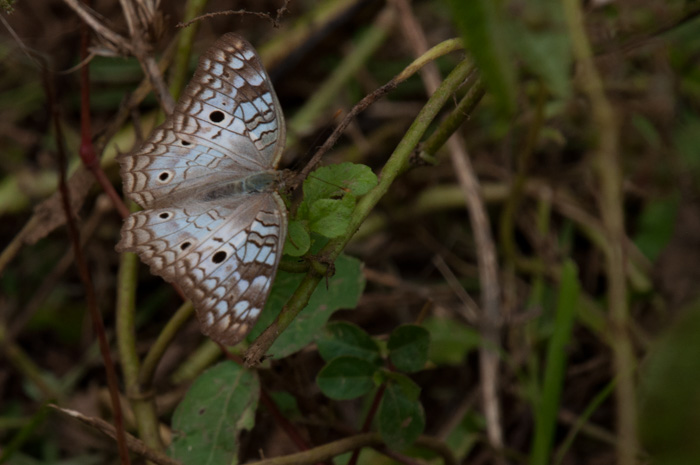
[42, 53, 131, 465]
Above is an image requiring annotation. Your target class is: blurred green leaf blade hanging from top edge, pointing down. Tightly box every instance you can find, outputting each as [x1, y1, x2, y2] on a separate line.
[448, 0, 516, 115]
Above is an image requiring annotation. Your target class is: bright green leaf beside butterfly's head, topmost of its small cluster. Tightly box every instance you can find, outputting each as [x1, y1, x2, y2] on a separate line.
[304, 163, 377, 205]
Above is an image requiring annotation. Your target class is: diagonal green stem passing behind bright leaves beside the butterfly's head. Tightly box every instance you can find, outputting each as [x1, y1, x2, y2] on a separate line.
[245, 60, 471, 365]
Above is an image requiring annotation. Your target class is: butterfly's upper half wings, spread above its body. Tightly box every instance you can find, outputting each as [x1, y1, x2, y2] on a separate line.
[118, 34, 285, 208]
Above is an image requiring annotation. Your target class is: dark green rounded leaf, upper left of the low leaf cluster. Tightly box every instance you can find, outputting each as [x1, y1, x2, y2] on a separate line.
[316, 321, 381, 365]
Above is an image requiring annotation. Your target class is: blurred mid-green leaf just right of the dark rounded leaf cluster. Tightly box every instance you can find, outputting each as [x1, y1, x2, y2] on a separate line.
[423, 317, 481, 365]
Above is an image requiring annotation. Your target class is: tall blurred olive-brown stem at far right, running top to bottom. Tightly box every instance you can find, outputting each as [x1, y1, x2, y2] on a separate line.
[564, 0, 639, 465]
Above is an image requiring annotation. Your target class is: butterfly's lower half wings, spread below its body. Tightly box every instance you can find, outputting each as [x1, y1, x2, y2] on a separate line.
[117, 193, 287, 345]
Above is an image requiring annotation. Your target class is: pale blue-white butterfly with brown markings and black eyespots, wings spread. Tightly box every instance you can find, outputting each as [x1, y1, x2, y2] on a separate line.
[117, 33, 287, 345]
